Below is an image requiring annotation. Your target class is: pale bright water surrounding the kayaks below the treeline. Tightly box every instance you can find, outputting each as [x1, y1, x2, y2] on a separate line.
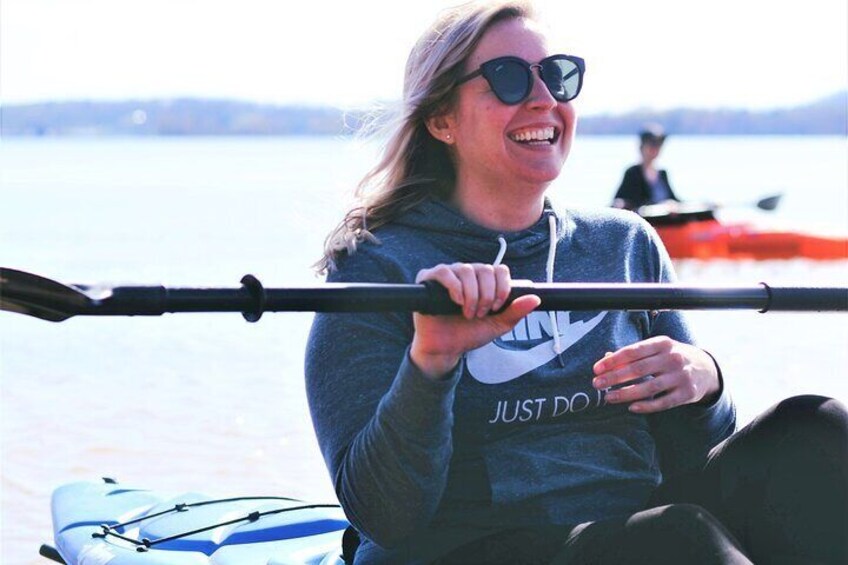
[0, 137, 848, 564]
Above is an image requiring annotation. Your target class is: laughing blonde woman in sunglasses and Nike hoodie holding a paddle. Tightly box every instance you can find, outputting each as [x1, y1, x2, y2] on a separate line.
[305, 1, 848, 565]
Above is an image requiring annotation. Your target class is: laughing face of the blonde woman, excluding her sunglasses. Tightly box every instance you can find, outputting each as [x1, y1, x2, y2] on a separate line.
[448, 18, 576, 191]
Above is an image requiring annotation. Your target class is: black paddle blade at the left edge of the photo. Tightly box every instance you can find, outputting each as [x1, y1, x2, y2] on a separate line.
[0, 267, 91, 322]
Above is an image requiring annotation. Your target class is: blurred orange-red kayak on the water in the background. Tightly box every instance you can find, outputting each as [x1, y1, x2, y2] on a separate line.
[640, 209, 848, 260]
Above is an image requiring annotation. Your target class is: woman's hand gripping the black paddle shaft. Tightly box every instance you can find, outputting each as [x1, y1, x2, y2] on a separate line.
[409, 263, 541, 379]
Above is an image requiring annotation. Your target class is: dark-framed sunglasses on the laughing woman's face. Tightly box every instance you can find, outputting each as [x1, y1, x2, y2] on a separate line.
[456, 55, 586, 105]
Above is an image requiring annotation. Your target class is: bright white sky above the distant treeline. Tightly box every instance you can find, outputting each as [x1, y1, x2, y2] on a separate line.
[0, 0, 848, 114]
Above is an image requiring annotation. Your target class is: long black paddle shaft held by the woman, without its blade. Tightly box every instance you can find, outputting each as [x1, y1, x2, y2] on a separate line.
[53, 283, 848, 321]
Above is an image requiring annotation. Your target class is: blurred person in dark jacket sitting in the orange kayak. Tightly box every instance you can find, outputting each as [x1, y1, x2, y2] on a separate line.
[612, 124, 679, 210]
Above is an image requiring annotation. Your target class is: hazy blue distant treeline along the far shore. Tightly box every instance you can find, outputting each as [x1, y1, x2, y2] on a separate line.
[0, 91, 848, 136]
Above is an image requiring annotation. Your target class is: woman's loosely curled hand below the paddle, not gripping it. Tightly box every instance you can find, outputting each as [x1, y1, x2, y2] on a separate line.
[592, 336, 721, 414]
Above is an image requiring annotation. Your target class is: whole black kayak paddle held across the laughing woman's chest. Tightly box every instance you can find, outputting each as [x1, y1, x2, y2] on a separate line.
[0, 267, 848, 322]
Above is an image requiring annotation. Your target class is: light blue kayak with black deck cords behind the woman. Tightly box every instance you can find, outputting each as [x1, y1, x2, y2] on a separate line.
[41, 479, 349, 565]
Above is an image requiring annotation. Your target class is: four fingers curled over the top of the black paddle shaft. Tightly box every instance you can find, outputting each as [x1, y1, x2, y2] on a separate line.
[415, 263, 517, 321]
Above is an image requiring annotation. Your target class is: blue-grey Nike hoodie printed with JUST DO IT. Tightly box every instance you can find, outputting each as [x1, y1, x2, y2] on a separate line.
[306, 197, 735, 563]
